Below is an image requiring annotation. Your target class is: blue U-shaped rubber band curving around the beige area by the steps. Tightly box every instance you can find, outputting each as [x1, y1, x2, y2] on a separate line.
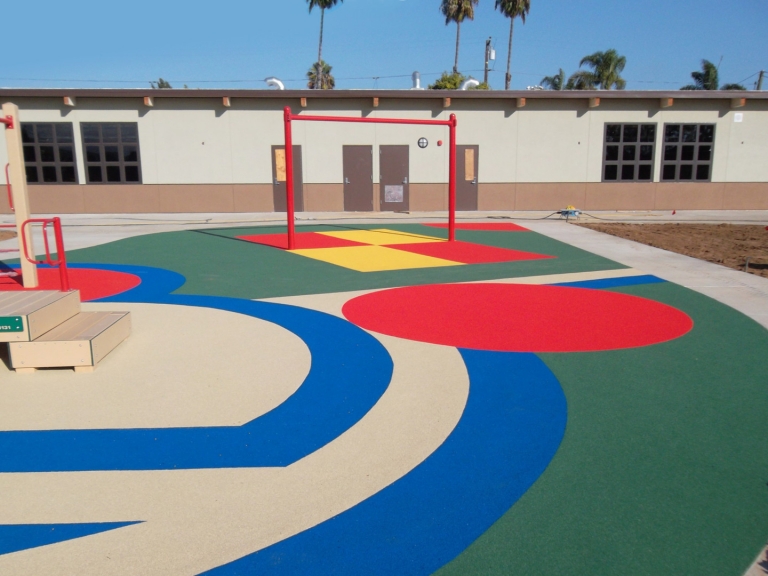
[0, 265, 393, 472]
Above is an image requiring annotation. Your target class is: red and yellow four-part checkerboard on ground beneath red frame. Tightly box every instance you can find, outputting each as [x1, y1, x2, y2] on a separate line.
[238, 228, 552, 272]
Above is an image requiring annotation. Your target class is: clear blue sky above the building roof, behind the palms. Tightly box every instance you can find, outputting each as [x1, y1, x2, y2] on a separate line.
[6, 0, 768, 90]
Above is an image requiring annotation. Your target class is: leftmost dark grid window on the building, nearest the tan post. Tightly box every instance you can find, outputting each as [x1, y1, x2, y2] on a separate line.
[21, 122, 77, 184]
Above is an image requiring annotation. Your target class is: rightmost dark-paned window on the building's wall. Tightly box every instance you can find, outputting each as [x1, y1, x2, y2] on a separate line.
[661, 124, 715, 182]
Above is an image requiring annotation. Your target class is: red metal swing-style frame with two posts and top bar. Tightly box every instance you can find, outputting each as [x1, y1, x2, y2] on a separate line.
[284, 106, 456, 250]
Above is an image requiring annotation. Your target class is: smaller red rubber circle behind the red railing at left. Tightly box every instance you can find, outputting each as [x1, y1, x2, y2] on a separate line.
[0, 268, 141, 302]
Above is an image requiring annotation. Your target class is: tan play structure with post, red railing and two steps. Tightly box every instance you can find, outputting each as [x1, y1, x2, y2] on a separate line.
[0, 104, 131, 373]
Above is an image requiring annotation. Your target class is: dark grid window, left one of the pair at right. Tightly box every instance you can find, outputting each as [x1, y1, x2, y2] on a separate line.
[603, 124, 656, 182]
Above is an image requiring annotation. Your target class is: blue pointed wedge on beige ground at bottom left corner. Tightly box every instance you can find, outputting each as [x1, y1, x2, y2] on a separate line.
[0, 522, 140, 555]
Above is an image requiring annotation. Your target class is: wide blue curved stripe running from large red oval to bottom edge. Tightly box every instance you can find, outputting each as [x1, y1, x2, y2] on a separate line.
[201, 350, 567, 576]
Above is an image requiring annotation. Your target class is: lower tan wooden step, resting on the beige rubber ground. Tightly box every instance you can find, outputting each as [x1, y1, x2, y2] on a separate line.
[8, 312, 131, 372]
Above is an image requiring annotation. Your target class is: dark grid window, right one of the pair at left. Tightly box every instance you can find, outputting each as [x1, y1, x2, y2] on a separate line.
[80, 122, 141, 184]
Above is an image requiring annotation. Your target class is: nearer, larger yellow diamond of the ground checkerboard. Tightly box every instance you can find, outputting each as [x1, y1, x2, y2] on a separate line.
[292, 246, 463, 272]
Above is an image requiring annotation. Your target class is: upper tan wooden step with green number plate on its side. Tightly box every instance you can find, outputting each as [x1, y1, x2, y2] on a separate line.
[0, 290, 80, 342]
